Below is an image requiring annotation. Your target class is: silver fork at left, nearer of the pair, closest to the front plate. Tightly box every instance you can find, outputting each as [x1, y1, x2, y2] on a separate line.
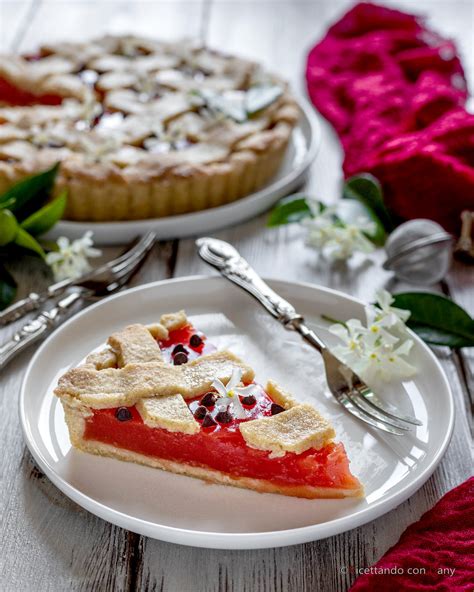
[0, 233, 155, 370]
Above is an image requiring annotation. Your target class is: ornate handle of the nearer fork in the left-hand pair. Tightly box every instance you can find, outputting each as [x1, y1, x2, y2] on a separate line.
[0, 291, 83, 369]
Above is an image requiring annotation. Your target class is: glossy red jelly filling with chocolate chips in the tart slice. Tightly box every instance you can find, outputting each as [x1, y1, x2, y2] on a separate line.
[84, 325, 356, 488]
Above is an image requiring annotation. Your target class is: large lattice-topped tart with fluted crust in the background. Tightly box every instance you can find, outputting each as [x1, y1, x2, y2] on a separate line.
[0, 36, 299, 221]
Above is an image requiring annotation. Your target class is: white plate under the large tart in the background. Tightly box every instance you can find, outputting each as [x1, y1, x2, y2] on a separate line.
[45, 98, 321, 245]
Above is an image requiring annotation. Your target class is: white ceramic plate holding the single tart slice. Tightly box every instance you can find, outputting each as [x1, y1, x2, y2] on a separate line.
[20, 277, 453, 549]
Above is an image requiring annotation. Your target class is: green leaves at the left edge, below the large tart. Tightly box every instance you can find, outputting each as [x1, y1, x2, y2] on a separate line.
[0, 164, 67, 309]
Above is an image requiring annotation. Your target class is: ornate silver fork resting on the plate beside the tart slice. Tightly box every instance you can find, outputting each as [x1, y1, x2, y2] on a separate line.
[196, 238, 422, 436]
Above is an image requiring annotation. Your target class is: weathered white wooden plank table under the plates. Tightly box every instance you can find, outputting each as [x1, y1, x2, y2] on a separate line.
[0, 0, 474, 592]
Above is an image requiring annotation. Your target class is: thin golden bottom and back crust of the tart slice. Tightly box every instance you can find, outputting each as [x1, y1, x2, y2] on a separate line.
[63, 401, 364, 499]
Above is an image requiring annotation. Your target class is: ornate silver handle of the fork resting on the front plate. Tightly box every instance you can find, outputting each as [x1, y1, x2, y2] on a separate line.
[196, 237, 303, 326]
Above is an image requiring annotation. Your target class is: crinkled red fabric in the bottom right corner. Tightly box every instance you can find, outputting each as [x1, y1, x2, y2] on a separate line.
[350, 477, 474, 592]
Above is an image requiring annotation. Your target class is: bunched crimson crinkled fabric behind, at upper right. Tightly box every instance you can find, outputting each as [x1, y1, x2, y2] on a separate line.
[306, 3, 474, 230]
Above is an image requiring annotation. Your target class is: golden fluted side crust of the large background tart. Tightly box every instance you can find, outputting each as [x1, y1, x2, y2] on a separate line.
[0, 122, 293, 222]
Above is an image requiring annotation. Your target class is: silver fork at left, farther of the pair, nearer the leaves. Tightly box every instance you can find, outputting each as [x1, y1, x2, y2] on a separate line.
[0, 232, 155, 326]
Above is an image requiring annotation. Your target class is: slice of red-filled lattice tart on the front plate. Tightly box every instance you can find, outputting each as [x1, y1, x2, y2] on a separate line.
[55, 311, 363, 498]
